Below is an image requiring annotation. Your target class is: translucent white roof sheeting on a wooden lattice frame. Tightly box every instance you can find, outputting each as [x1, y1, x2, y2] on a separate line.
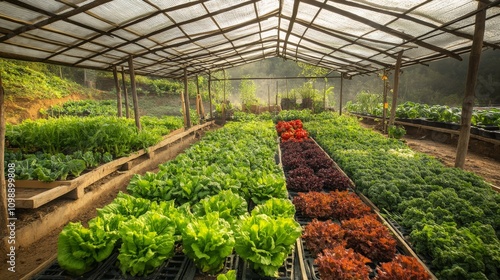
[0, 0, 500, 78]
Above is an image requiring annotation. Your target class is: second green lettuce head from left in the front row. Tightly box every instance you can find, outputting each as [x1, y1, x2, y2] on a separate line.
[118, 211, 175, 276]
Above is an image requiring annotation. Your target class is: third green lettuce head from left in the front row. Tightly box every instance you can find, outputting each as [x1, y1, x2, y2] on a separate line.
[182, 212, 235, 274]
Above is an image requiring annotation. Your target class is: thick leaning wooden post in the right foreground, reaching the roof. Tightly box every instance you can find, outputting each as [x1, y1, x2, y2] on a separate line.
[455, 1, 486, 168]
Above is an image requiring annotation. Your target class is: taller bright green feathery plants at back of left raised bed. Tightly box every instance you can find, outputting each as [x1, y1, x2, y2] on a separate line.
[6, 116, 181, 157]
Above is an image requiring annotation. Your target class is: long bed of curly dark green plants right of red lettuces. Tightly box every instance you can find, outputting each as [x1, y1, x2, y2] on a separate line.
[304, 114, 500, 279]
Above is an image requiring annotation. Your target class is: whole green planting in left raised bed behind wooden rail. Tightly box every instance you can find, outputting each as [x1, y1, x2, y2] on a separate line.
[5, 117, 182, 182]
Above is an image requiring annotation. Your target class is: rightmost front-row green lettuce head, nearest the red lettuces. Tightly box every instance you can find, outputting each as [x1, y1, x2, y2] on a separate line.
[234, 214, 302, 277]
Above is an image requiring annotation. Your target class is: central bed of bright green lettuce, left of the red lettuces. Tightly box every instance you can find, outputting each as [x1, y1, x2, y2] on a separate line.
[58, 121, 302, 279]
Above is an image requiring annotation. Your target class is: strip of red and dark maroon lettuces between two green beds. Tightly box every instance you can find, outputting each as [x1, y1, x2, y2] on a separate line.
[276, 120, 430, 280]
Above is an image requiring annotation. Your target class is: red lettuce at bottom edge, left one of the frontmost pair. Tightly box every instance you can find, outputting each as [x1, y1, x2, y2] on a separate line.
[314, 245, 370, 280]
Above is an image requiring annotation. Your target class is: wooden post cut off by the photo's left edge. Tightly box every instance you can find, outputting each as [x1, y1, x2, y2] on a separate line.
[0, 72, 10, 245]
